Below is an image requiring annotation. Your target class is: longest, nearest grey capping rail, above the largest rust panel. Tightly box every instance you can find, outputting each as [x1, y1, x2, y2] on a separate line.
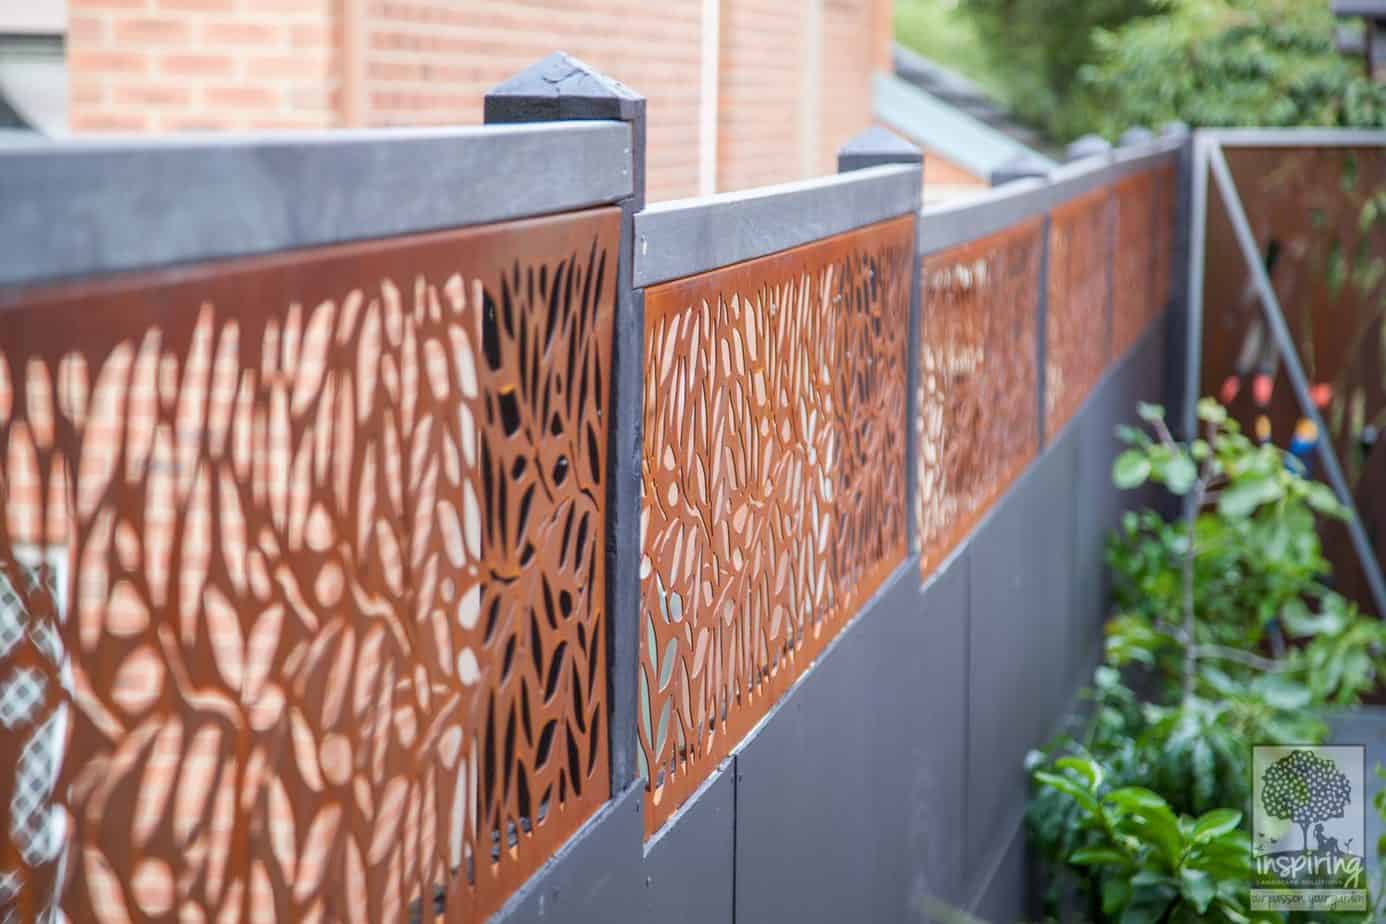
[0, 122, 632, 285]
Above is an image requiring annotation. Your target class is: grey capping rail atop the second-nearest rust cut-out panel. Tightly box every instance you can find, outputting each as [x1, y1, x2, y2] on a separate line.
[635, 165, 923, 285]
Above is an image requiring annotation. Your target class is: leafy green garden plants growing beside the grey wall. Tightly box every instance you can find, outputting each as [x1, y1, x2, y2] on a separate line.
[1027, 399, 1386, 924]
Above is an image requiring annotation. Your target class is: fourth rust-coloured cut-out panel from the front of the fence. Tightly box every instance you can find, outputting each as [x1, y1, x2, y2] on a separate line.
[1045, 187, 1116, 443]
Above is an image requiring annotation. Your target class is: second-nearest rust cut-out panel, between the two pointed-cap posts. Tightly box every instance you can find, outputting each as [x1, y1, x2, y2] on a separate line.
[638, 216, 915, 833]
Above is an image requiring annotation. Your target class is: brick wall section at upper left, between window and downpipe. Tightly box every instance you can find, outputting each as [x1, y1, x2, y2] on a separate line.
[68, 0, 338, 132]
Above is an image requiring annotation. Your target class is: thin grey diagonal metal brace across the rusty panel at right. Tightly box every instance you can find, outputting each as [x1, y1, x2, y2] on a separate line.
[1209, 147, 1386, 619]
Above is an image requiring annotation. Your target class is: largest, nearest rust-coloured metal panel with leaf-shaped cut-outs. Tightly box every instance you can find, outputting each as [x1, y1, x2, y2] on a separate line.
[0, 209, 620, 923]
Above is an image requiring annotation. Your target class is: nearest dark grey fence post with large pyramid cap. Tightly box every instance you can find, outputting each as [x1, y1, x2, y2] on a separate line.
[485, 51, 644, 798]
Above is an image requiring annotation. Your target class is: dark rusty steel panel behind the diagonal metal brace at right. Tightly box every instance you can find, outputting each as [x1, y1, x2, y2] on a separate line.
[1199, 137, 1386, 607]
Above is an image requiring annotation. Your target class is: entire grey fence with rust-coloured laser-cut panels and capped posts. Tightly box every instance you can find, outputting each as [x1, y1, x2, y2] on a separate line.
[0, 54, 1182, 924]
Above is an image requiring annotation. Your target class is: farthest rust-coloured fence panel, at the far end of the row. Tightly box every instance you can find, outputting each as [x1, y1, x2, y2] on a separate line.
[1112, 170, 1168, 359]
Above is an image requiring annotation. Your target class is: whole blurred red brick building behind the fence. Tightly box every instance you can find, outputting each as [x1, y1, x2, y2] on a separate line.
[0, 0, 891, 199]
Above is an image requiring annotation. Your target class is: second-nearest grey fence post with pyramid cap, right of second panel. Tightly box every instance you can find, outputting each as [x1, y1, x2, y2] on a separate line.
[837, 126, 924, 553]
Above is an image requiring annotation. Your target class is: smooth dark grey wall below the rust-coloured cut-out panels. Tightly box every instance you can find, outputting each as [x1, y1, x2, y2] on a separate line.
[487, 319, 1166, 924]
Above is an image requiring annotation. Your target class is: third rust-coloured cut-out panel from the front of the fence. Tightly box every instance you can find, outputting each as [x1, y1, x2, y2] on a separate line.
[915, 219, 1044, 575]
